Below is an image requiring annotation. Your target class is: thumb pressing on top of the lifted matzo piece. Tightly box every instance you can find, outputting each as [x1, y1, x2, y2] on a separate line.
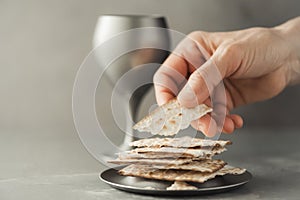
[178, 45, 239, 108]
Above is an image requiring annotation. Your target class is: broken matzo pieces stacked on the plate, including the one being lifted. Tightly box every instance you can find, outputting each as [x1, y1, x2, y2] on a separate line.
[109, 100, 246, 190]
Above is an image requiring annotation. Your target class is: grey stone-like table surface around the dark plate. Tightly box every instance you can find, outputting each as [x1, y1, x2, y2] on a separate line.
[0, 129, 300, 200]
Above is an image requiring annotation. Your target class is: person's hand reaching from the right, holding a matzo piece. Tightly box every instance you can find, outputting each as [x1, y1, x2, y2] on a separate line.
[154, 18, 300, 136]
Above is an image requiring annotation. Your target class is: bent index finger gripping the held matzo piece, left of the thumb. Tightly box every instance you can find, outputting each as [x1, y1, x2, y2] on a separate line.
[154, 34, 205, 105]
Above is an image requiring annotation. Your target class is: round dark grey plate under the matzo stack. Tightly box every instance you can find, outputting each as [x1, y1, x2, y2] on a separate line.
[100, 167, 252, 196]
